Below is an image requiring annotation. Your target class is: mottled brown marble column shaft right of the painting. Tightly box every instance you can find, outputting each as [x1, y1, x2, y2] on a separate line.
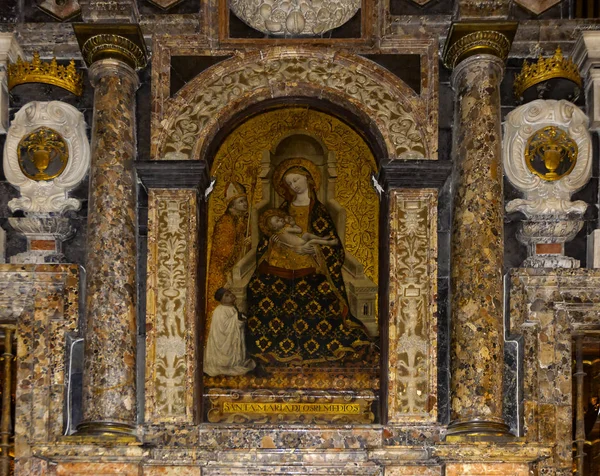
[448, 24, 510, 435]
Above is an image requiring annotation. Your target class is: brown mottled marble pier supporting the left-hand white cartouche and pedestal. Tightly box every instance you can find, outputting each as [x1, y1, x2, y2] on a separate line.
[0, 264, 79, 474]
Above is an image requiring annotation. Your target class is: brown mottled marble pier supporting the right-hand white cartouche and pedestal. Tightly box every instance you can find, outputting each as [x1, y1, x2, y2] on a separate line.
[510, 268, 600, 474]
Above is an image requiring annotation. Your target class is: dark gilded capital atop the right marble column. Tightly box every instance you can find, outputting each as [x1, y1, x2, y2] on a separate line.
[442, 22, 518, 69]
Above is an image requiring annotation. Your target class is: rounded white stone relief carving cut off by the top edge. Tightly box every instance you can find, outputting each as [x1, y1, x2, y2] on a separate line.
[229, 0, 361, 36]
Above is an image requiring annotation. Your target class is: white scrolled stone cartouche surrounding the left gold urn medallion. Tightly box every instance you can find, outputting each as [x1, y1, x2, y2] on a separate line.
[4, 101, 90, 213]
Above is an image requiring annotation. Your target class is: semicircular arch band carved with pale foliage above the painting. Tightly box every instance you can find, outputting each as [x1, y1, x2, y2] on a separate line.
[151, 47, 437, 160]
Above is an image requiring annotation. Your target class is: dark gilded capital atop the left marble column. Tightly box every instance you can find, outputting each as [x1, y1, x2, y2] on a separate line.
[73, 23, 148, 70]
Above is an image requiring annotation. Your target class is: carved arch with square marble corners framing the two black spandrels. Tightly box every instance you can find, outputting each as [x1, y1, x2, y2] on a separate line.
[150, 35, 438, 164]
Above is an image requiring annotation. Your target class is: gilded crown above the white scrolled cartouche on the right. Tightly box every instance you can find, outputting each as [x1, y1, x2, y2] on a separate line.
[513, 47, 583, 98]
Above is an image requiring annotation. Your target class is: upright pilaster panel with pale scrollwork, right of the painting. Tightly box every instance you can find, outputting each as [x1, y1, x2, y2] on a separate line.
[388, 189, 437, 423]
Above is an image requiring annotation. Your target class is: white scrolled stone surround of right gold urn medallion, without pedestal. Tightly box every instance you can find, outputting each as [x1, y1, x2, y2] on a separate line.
[503, 99, 592, 216]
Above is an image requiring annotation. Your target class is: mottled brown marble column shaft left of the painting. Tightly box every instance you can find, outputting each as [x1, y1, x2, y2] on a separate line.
[78, 28, 146, 436]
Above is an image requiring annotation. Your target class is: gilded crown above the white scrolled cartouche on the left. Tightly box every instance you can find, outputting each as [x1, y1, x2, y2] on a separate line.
[8, 51, 83, 96]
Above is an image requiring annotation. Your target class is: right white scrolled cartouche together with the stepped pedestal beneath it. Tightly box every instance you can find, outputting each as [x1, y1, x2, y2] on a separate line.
[502, 99, 592, 268]
